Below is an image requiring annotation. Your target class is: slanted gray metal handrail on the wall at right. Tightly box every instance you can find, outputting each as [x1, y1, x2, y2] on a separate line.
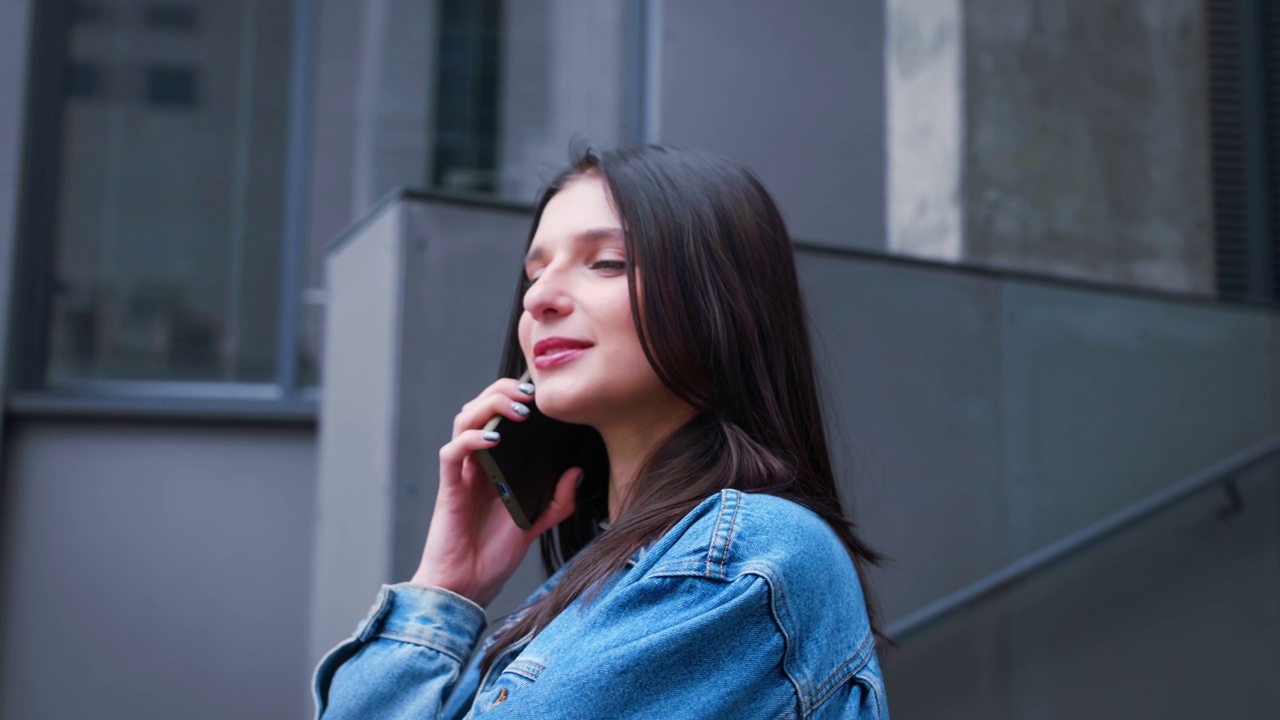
[886, 427, 1280, 642]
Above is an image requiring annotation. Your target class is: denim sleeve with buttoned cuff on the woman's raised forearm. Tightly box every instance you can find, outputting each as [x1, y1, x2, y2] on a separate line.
[312, 583, 485, 720]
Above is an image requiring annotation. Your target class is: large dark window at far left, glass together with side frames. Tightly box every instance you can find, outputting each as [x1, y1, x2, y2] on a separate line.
[14, 0, 314, 396]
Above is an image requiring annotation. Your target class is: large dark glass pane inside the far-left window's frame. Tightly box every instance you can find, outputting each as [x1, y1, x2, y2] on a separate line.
[41, 0, 293, 387]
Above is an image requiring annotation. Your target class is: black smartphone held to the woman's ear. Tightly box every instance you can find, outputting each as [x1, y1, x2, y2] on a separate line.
[476, 372, 599, 530]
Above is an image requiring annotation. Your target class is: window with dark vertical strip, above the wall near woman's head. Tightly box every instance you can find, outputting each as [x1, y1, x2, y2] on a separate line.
[357, 0, 641, 206]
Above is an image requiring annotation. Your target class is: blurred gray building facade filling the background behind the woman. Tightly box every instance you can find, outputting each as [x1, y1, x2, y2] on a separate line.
[0, 0, 1280, 719]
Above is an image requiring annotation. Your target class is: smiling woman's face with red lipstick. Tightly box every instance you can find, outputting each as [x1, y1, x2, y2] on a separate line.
[518, 174, 678, 429]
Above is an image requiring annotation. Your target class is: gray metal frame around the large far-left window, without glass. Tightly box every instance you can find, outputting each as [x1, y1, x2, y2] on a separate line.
[5, 0, 320, 421]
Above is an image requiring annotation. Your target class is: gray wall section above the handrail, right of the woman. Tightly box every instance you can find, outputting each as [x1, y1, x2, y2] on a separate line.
[799, 251, 1280, 614]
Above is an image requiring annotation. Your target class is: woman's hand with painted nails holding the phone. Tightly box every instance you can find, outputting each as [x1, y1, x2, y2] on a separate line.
[411, 378, 582, 607]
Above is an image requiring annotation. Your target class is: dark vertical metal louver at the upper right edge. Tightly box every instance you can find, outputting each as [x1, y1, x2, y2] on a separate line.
[1204, 0, 1280, 302]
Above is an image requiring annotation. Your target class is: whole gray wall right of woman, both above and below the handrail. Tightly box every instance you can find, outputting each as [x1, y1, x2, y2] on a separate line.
[799, 252, 1280, 719]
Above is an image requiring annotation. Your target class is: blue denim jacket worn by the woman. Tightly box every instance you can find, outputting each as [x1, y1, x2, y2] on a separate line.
[312, 491, 888, 720]
